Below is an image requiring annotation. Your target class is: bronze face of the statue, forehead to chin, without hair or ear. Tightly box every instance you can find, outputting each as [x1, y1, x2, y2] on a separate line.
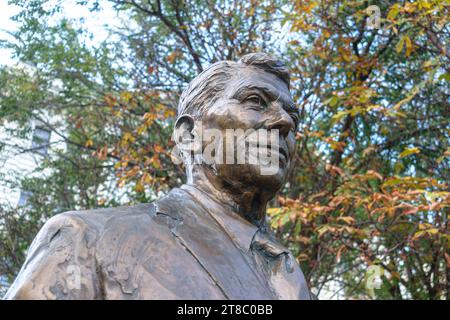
[202, 67, 298, 191]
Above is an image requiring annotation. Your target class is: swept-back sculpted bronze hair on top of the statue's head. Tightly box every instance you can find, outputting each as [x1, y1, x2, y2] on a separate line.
[178, 52, 290, 119]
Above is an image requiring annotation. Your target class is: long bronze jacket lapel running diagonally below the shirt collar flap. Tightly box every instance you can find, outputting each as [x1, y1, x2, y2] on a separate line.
[157, 189, 274, 299]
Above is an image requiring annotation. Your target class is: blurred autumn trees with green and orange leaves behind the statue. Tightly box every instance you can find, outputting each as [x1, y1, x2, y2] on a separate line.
[0, 0, 450, 299]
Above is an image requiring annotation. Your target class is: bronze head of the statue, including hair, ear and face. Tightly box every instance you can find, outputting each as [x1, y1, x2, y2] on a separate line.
[174, 53, 298, 194]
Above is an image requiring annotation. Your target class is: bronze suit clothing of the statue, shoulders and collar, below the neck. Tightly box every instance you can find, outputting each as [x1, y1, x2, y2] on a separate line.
[5, 185, 311, 299]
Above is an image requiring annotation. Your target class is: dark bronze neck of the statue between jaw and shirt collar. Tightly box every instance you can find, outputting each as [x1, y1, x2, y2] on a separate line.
[187, 166, 273, 227]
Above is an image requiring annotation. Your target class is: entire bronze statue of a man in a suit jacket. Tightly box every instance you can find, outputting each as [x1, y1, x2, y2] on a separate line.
[5, 53, 312, 299]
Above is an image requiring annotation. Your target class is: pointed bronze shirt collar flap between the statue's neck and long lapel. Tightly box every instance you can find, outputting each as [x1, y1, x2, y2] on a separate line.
[181, 184, 259, 252]
